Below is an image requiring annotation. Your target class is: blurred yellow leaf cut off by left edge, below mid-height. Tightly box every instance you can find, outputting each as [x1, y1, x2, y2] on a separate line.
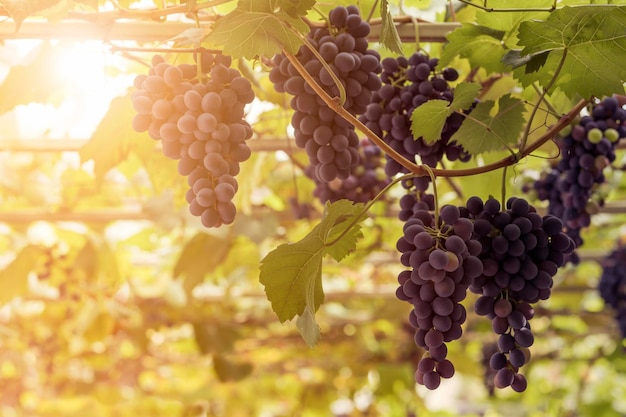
[0, 245, 45, 304]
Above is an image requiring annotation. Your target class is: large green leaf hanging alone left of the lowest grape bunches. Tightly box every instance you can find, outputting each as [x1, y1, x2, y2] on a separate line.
[260, 200, 364, 343]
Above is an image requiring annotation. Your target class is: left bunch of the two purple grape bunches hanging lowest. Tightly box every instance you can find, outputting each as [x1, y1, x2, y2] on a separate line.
[396, 205, 483, 389]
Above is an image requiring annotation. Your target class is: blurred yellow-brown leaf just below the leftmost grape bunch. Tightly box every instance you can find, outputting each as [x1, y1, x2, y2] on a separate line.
[174, 232, 232, 294]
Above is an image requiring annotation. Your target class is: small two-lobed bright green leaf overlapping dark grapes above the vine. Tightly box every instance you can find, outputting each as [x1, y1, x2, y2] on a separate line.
[411, 82, 480, 144]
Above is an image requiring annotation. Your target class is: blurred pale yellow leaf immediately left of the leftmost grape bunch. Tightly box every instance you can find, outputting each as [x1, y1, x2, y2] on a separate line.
[79, 95, 156, 182]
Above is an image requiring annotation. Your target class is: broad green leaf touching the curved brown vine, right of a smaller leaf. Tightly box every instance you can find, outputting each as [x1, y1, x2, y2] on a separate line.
[450, 94, 524, 155]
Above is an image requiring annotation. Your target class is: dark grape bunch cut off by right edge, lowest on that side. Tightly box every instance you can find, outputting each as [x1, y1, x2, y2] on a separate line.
[598, 237, 626, 338]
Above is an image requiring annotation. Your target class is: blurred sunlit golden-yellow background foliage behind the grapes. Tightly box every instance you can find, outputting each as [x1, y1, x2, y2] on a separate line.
[0, 1, 626, 417]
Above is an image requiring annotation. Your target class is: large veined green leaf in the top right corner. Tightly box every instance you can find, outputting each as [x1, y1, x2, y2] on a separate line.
[515, 5, 626, 98]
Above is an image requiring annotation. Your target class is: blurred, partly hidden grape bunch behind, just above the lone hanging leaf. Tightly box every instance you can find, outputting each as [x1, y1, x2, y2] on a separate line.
[307, 139, 390, 203]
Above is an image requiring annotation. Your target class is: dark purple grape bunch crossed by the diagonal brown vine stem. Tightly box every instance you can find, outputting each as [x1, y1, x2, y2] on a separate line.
[269, 6, 381, 182]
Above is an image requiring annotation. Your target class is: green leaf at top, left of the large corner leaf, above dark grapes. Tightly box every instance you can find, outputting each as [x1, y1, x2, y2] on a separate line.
[439, 23, 506, 73]
